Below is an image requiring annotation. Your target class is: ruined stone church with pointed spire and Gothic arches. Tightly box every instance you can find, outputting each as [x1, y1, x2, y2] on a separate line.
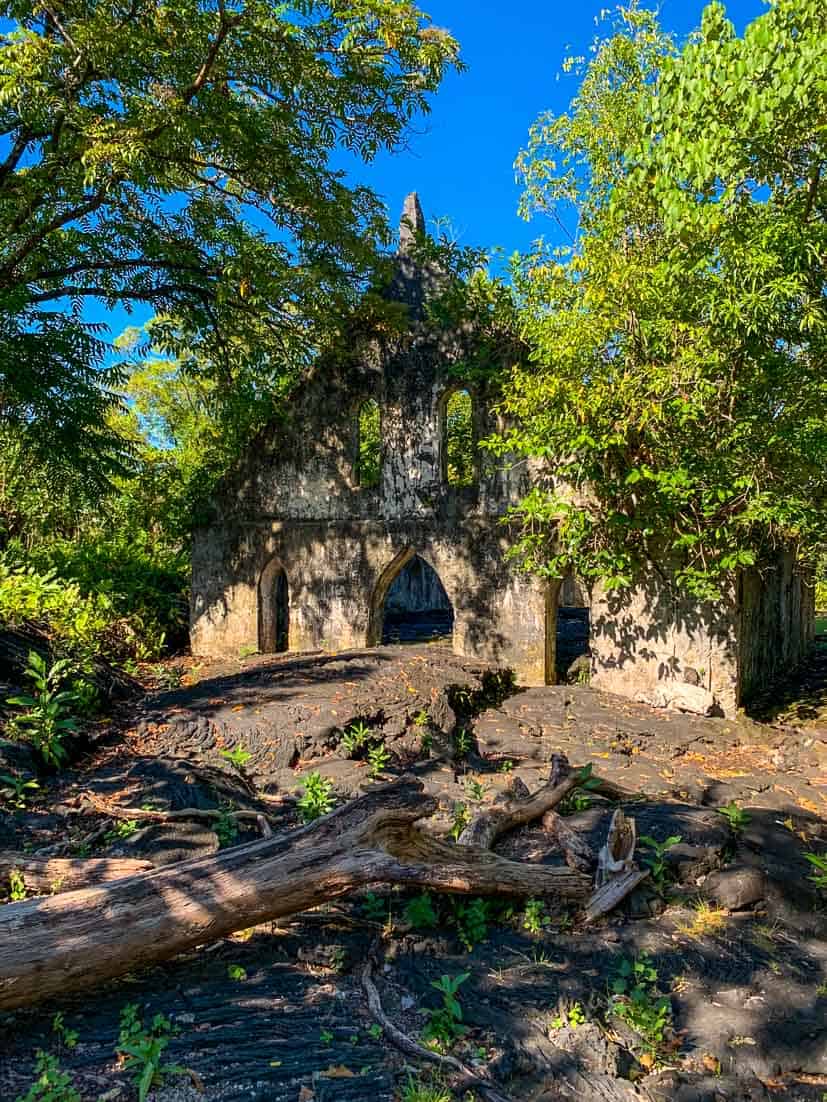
[191, 195, 814, 715]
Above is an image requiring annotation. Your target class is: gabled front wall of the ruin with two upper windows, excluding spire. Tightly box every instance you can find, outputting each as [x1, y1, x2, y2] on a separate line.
[191, 328, 546, 684]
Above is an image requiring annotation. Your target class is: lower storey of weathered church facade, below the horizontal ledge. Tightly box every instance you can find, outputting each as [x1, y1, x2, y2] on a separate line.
[192, 520, 546, 684]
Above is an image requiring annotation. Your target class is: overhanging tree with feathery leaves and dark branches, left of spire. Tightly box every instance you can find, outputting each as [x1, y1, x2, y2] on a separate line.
[0, 0, 460, 472]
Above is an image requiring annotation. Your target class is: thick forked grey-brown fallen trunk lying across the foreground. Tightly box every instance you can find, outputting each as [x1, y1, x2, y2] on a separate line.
[0, 778, 590, 1011]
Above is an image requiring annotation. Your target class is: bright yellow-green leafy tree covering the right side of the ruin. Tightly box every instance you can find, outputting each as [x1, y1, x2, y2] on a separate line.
[493, 0, 827, 597]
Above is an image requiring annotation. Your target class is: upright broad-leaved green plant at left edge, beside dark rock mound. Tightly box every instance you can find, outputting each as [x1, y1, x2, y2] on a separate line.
[6, 650, 77, 766]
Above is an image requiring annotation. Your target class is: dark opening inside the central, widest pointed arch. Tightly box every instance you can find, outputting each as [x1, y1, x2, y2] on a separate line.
[382, 555, 453, 642]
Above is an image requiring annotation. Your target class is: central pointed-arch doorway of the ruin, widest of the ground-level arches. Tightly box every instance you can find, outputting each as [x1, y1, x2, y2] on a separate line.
[368, 548, 453, 646]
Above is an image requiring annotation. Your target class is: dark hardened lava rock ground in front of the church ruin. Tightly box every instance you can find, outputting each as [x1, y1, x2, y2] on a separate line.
[0, 646, 827, 1102]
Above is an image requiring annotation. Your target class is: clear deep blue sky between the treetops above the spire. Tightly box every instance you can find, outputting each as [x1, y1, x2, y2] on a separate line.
[87, 0, 766, 337]
